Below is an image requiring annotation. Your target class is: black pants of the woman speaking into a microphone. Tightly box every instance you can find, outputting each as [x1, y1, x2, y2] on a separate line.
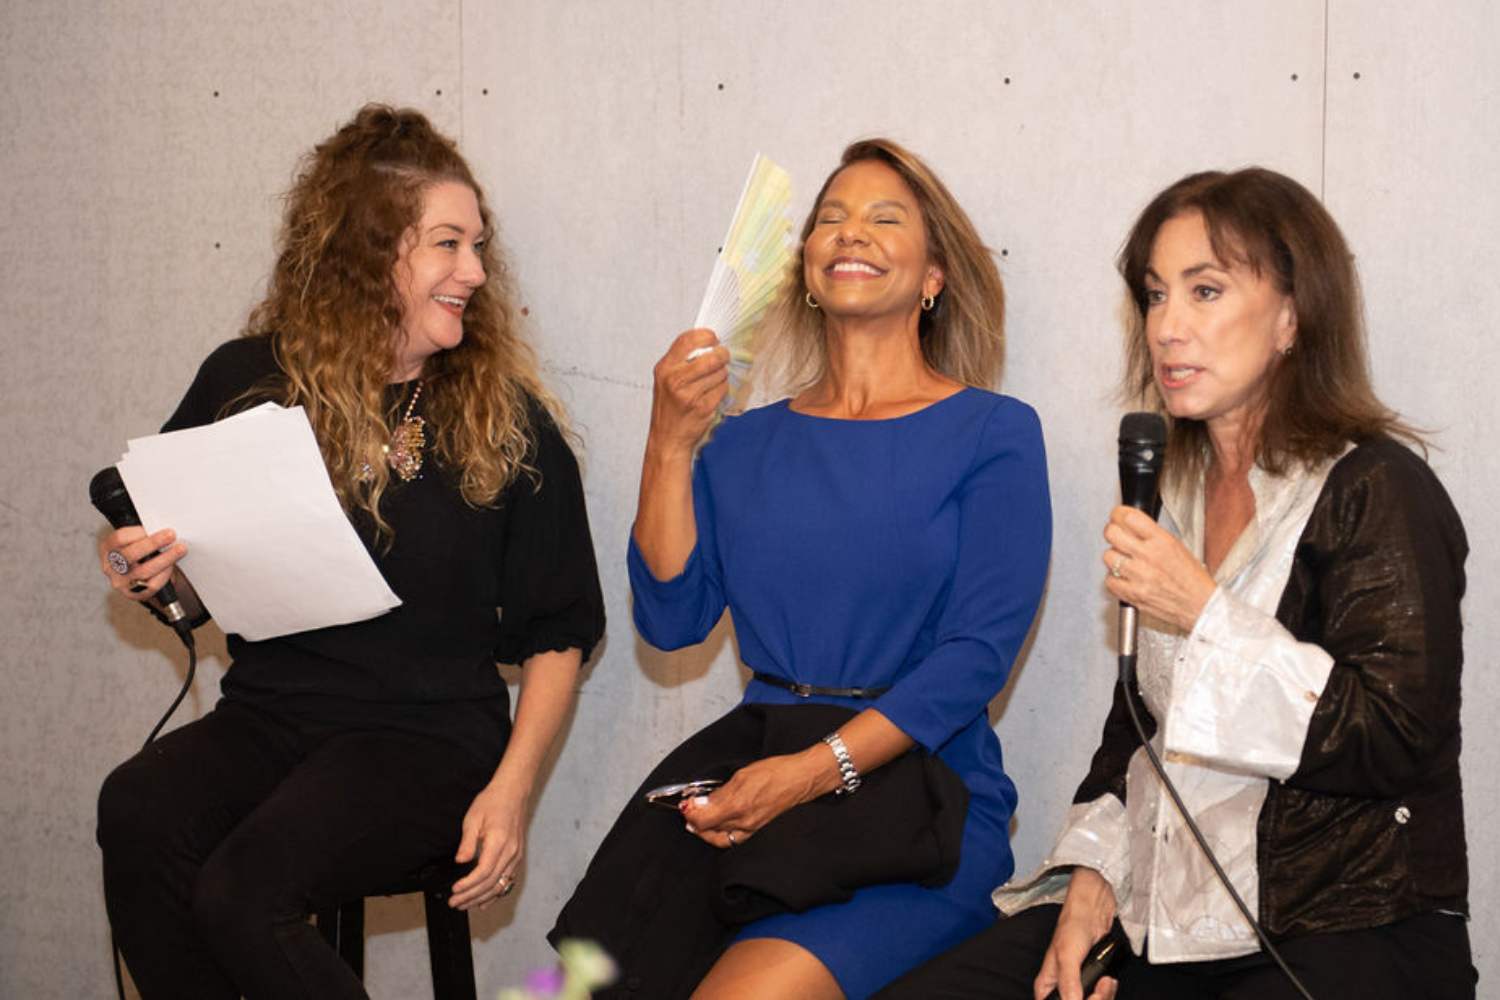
[876, 906, 1479, 1000]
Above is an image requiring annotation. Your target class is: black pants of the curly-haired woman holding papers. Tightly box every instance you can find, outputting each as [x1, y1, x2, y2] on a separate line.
[99, 703, 498, 1000]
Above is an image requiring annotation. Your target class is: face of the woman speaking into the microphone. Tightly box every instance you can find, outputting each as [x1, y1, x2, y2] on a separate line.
[1146, 211, 1296, 435]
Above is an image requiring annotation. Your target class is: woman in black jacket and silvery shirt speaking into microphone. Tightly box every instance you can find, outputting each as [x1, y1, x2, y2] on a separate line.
[884, 169, 1475, 1000]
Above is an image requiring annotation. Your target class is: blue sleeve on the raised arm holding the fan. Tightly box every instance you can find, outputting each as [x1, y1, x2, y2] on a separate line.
[626, 448, 725, 649]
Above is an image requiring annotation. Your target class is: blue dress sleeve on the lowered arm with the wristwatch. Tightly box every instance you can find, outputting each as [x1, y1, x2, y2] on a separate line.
[875, 400, 1052, 751]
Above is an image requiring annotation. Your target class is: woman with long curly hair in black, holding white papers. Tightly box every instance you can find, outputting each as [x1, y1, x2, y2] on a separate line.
[99, 105, 603, 1000]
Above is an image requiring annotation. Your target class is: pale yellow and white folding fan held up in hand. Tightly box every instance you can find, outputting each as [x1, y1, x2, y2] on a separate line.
[693, 154, 794, 397]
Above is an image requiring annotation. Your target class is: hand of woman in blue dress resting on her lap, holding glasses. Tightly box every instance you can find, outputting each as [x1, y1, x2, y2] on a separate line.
[680, 744, 839, 847]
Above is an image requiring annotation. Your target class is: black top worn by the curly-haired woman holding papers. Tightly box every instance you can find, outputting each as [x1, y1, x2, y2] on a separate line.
[162, 337, 605, 763]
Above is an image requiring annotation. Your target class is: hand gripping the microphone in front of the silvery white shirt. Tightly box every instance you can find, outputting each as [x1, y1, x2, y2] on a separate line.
[1104, 507, 1218, 631]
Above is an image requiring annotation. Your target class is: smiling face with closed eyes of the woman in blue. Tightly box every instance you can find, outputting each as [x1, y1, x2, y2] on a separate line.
[803, 160, 944, 318]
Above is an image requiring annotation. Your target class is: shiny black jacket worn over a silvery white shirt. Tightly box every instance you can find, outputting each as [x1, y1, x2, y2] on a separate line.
[1074, 439, 1469, 937]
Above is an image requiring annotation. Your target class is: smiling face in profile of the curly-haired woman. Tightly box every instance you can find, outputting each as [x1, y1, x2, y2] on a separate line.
[393, 181, 486, 381]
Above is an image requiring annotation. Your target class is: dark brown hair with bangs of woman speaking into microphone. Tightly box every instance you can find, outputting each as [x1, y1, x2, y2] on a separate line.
[1119, 166, 1422, 478]
